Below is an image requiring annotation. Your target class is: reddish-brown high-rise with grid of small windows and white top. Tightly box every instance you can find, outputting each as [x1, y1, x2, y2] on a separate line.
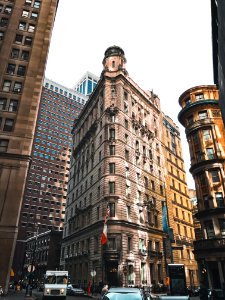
[13, 79, 87, 277]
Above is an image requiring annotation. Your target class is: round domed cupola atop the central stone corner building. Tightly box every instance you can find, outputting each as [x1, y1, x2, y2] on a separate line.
[102, 46, 127, 75]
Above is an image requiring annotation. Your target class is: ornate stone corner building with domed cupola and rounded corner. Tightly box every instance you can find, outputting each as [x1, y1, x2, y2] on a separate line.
[61, 46, 175, 286]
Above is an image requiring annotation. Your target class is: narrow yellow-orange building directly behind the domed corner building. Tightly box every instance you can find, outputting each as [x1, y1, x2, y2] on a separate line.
[163, 115, 199, 287]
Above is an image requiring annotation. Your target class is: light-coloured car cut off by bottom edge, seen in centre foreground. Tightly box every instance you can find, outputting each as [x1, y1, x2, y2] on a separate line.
[102, 287, 151, 300]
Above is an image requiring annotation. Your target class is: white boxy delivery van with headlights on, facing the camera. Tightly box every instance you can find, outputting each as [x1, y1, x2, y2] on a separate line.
[43, 271, 68, 300]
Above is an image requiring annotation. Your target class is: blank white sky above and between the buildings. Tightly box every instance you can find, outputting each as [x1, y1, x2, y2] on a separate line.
[45, 0, 213, 188]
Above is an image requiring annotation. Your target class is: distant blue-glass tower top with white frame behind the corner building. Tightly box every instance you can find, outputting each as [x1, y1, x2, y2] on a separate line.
[74, 71, 99, 96]
